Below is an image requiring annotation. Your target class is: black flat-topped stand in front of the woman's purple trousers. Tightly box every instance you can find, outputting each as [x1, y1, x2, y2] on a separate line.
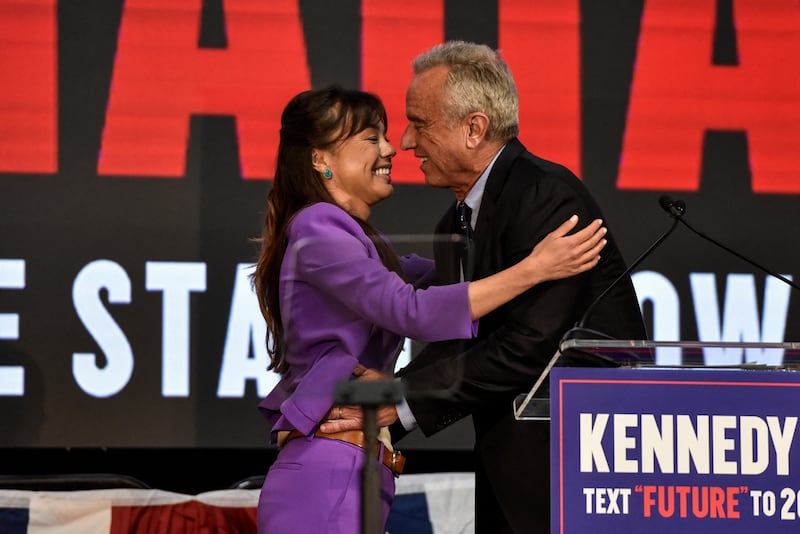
[334, 380, 403, 534]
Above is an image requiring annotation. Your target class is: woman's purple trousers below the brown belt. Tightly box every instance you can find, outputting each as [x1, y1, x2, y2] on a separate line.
[258, 438, 395, 534]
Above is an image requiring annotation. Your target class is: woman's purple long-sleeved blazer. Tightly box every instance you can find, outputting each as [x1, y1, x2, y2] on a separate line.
[259, 202, 477, 442]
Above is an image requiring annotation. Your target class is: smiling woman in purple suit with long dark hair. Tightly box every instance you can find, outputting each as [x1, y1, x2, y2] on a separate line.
[253, 87, 605, 534]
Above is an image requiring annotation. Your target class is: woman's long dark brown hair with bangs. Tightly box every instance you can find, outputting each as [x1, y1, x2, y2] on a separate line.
[251, 85, 402, 374]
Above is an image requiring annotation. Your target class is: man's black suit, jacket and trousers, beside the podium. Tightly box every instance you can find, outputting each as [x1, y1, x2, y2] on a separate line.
[393, 139, 647, 534]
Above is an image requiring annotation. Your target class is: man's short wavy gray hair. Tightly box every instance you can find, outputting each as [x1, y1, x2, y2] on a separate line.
[412, 41, 519, 141]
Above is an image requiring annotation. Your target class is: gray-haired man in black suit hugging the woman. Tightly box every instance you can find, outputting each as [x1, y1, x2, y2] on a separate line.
[329, 41, 647, 534]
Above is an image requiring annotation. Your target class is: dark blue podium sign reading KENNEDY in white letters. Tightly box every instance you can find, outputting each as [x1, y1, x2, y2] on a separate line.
[550, 367, 800, 534]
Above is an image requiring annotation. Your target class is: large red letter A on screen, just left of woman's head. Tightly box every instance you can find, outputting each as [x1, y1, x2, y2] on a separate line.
[98, 0, 310, 178]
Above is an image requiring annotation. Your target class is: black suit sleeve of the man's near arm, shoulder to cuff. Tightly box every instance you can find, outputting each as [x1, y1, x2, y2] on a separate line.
[398, 178, 604, 436]
